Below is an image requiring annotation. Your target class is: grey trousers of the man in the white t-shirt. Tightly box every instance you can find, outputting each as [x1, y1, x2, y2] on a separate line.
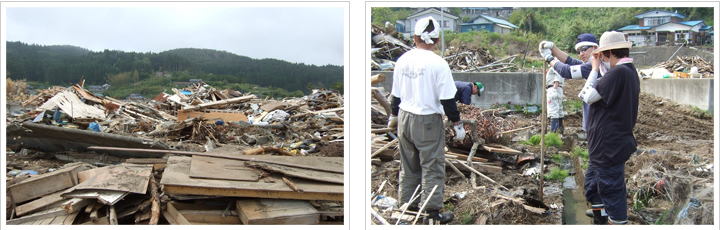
[398, 109, 445, 210]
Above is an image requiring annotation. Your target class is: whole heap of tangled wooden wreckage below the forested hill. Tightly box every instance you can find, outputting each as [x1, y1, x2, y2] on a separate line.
[6, 81, 344, 225]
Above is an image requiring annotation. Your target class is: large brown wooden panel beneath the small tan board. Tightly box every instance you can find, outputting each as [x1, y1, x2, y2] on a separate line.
[160, 156, 344, 201]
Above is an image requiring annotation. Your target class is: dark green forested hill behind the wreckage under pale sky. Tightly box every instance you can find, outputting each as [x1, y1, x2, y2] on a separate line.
[7, 42, 343, 93]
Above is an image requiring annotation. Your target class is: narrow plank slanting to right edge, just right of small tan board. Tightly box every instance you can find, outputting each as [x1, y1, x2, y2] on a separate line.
[245, 161, 345, 184]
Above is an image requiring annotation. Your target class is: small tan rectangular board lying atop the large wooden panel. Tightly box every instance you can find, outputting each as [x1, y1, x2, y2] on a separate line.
[190, 156, 262, 181]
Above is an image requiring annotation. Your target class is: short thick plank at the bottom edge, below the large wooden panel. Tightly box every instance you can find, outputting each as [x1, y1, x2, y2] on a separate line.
[235, 199, 320, 225]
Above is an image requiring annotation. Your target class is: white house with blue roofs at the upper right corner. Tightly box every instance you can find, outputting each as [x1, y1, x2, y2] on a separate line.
[618, 10, 714, 46]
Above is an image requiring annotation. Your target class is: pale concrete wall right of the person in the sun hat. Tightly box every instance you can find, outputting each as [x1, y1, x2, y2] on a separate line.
[640, 78, 715, 113]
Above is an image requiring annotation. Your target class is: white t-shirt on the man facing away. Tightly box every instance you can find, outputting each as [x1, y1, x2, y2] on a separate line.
[392, 49, 457, 115]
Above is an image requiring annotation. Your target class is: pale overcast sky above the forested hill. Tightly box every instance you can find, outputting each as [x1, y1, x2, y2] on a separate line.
[6, 7, 347, 65]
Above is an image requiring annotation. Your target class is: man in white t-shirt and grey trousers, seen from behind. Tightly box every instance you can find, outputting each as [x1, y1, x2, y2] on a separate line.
[388, 17, 465, 224]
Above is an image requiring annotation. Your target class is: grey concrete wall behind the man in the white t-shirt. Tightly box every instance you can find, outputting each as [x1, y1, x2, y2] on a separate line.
[372, 71, 543, 108]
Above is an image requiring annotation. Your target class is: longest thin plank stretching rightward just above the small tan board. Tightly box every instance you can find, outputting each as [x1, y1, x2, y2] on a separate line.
[88, 146, 345, 173]
